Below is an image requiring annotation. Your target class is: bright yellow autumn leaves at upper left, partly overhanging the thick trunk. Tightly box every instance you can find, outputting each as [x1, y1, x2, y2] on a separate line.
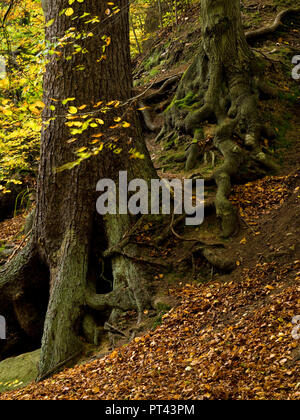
[0, 0, 142, 184]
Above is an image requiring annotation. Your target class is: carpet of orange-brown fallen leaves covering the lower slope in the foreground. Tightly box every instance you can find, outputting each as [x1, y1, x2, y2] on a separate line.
[0, 261, 300, 400]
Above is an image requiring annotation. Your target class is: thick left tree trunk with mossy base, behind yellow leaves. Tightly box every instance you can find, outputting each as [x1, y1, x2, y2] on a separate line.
[1, 0, 156, 379]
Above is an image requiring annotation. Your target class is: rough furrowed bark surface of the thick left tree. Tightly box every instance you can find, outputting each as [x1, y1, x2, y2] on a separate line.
[34, 0, 157, 378]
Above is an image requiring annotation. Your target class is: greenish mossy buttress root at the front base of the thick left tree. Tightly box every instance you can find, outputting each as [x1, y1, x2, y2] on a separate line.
[37, 232, 88, 380]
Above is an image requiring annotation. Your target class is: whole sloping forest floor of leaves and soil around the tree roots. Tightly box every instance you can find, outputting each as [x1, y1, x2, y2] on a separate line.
[0, 1, 300, 400]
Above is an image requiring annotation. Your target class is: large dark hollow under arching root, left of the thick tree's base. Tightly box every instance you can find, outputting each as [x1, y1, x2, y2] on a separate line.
[0, 243, 49, 360]
